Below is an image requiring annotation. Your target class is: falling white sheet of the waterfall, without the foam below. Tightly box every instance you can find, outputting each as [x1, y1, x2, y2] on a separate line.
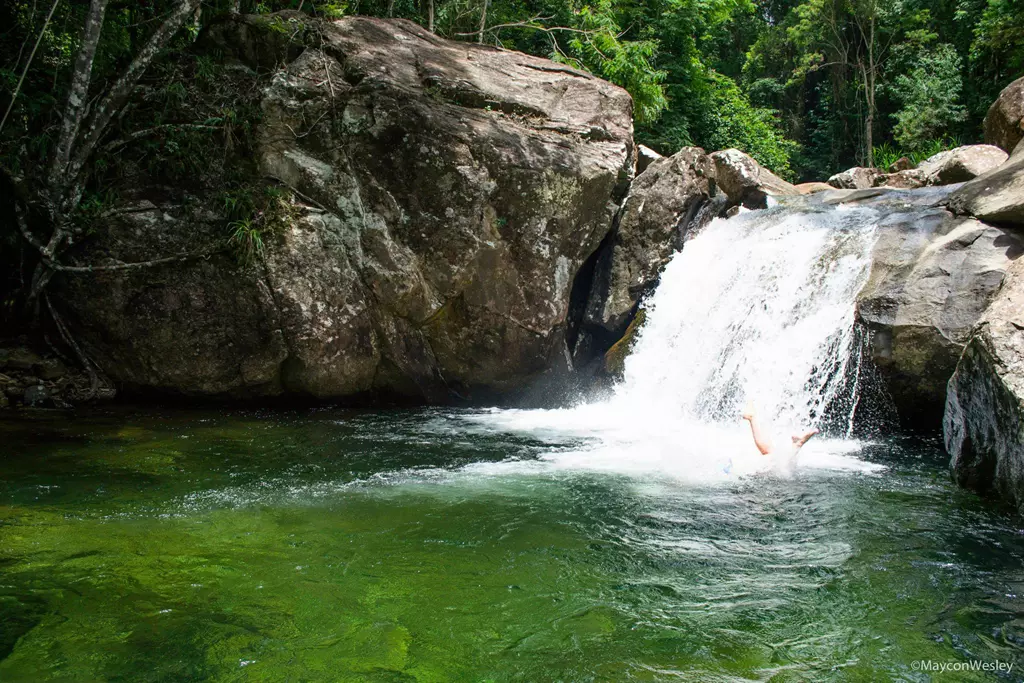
[612, 201, 878, 432]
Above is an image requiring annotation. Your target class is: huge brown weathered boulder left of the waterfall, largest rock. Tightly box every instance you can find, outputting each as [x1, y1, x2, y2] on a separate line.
[61, 17, 634, 401]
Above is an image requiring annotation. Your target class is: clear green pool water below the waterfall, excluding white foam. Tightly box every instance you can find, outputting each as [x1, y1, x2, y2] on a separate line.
[0, 411, 1024, 682]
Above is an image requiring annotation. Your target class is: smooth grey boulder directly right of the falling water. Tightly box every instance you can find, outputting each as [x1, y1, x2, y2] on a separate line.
[857, 202, 1024, 429]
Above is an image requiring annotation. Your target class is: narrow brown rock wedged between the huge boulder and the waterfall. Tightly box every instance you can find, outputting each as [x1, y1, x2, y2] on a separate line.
[578, 147, 716, 355]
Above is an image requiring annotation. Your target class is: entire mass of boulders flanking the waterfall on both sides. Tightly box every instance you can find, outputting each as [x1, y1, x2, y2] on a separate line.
[6, 13, 1024, 518]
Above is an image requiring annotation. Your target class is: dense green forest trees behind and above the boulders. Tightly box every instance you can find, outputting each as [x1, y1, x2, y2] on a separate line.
[0, 0, 1024, 184]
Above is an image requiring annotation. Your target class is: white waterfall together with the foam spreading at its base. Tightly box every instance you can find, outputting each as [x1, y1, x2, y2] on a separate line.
[468, 203, 880, 478]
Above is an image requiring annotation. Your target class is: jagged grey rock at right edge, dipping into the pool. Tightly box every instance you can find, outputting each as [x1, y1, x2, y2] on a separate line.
[943, 259, 1024, 510]
